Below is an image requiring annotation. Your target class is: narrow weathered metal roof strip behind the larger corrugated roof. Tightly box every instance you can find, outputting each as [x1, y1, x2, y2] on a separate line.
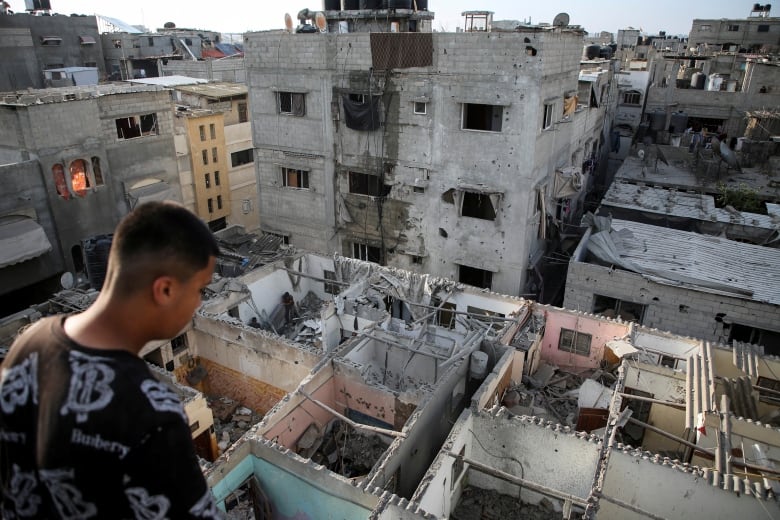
[601, 182, 780, 229]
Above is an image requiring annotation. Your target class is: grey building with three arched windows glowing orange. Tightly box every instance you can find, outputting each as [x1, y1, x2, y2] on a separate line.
[0, 84, 181, 304]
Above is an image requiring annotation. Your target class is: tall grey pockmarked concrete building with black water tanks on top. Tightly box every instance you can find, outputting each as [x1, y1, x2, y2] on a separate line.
[245, 9, 604, 296]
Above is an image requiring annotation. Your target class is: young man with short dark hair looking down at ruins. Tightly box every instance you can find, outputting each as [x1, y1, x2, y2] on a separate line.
[0, 202, 225, 520]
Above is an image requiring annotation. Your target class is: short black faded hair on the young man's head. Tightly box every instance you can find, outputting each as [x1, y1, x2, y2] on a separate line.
[109, 202, 219, 292]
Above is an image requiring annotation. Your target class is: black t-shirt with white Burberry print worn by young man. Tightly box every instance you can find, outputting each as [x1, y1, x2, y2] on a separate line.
[0, 316, 221, 520]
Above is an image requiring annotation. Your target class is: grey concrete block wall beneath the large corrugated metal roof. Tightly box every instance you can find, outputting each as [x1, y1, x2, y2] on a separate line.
[564, 262, 780, 343]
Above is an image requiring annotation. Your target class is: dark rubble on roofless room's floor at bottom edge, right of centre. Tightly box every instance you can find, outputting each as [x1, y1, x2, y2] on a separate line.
[450, 486, 561, 520]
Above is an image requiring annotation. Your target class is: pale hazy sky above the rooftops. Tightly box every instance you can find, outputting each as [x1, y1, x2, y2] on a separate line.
[6, 0, 756, 35]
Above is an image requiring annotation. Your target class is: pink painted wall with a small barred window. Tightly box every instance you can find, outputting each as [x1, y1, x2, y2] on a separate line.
[541, 309, 628, 369]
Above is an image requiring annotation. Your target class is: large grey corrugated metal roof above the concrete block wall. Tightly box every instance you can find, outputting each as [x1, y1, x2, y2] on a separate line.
[591, 220, 780, 305]
